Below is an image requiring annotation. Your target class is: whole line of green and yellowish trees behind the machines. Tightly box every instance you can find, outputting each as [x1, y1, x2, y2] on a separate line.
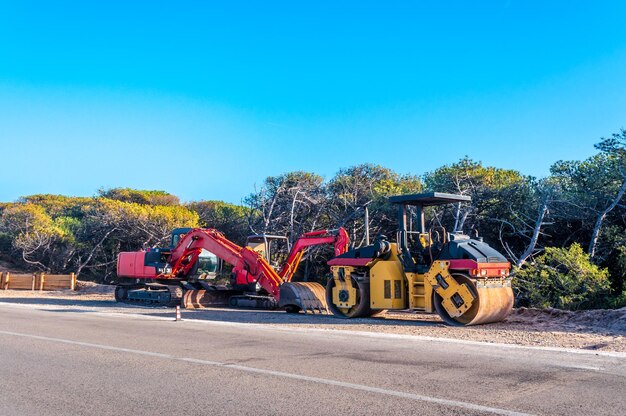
[0, 129, 626, 309]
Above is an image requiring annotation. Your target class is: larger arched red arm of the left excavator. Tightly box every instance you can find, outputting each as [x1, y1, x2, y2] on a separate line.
[163, 228, 283, 300]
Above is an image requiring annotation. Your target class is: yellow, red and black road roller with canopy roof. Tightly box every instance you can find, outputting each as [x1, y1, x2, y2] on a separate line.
[326, 192, 513, 325]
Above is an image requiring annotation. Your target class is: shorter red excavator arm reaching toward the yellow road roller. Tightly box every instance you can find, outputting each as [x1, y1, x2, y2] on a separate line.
[278, 227, 350, 282]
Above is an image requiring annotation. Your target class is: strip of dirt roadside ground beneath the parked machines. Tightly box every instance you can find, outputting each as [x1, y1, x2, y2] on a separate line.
[0, 282, 626, 352]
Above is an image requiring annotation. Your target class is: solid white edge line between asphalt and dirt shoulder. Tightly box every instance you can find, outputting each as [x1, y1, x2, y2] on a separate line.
[0, 301, 626, 358]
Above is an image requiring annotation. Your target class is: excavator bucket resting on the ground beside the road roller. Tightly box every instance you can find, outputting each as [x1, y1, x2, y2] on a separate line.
[278, 282, 328, 313]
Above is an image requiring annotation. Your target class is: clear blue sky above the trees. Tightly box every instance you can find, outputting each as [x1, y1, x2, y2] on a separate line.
[0, 0, 626, 202]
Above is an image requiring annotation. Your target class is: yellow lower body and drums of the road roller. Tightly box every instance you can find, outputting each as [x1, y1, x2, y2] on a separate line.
[329, 243, 513, 325]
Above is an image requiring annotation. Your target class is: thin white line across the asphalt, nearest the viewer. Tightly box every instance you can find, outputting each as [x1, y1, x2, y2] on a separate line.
[0, 331, 530, 416]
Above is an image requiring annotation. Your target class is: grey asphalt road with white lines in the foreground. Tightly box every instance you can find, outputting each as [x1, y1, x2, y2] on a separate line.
[0, 305, 626, 416]
